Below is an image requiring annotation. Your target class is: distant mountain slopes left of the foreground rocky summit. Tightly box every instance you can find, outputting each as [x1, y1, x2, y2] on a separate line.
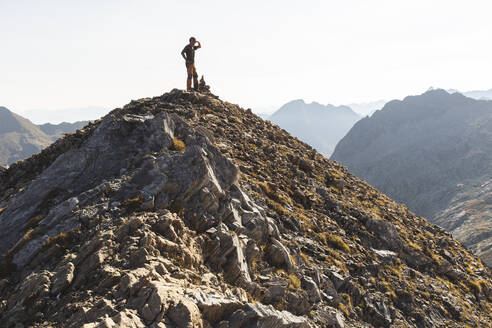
[0, 107, 88, 166]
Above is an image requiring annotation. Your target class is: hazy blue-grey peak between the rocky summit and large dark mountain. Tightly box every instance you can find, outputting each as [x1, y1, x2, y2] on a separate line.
[268, 99, 361, 157]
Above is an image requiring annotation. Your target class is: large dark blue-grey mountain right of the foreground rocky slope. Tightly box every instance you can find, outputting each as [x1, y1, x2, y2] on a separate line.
[331, 90, 492, 265]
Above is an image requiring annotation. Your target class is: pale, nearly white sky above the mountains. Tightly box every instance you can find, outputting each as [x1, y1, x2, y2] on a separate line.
[0, 0, 492, 118]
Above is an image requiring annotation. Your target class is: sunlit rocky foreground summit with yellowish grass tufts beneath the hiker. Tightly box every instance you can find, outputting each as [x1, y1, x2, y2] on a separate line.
[0, 90, 492, 328]
